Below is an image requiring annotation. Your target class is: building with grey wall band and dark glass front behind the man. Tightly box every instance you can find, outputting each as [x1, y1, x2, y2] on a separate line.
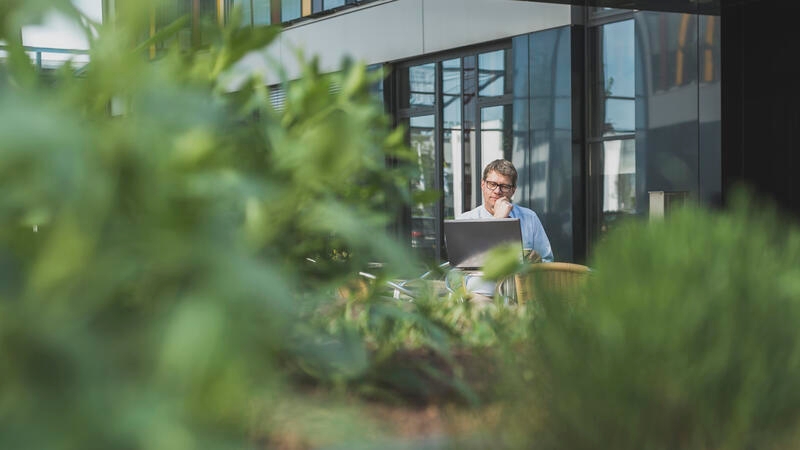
[111, 0, 800, 261]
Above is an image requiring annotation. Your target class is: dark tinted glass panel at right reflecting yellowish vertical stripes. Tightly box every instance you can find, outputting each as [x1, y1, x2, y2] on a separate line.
[634, 11, 696, 202]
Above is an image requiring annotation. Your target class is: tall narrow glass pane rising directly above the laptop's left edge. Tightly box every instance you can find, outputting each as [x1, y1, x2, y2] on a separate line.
[442, 59, 464, 219]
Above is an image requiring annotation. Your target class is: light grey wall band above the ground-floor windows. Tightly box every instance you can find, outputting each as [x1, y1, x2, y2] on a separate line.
[228, 0, 570, 84]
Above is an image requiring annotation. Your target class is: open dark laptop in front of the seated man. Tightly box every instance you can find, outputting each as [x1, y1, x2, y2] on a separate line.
[444, 218, 522, 270]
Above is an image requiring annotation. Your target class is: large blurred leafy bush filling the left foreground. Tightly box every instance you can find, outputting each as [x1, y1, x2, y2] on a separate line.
[0, 1, 428, 449]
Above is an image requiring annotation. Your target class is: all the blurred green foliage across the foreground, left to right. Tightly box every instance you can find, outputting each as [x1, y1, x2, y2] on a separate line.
[0, 0, 800, 449]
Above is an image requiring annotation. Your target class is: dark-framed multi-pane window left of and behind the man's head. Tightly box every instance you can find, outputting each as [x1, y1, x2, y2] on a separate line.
[395, 46, 512, 261]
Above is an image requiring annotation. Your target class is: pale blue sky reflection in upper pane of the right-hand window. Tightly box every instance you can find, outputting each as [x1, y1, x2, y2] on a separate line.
[603, 20, 635, 97]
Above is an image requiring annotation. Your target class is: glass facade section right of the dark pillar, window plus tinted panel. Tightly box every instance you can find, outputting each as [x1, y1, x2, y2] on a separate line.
[587, 11, 722, 250]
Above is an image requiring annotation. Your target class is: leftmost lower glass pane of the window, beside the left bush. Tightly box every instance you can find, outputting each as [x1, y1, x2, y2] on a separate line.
[409, 115, 439, 261]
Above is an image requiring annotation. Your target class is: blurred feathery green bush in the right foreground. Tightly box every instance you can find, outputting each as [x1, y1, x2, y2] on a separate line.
[509, 195, 800, 449]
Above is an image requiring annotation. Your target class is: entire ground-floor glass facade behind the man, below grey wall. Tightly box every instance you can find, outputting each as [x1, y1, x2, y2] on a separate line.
[395, 8, 722, 262]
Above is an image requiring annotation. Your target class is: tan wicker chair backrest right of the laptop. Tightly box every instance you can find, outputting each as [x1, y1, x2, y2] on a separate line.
[515, 262, 591, 304]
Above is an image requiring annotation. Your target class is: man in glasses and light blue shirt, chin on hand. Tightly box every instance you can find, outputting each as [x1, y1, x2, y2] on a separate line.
[457, 159, 553, 262]
